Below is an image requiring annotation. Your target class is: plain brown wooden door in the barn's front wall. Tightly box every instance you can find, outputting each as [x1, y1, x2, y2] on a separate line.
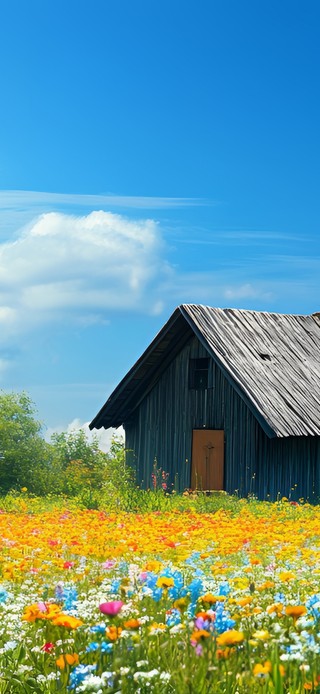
[191, 429, 224, 491]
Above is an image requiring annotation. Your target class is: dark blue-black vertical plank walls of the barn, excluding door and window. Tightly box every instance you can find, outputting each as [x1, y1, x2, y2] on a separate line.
[124, 337, 320, 501]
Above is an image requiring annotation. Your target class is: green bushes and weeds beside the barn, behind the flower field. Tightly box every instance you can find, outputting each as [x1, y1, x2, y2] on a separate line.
[0, 393, 242, 513]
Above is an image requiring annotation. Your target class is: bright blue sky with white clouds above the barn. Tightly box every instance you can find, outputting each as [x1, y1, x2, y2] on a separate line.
[0, 0, 320, 446]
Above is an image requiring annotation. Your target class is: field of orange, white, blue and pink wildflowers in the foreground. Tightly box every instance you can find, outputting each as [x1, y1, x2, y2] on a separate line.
[0, 500, 320, 694]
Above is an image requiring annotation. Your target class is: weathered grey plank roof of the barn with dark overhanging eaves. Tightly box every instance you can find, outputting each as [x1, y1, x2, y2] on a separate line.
[90, 304, 320, 437]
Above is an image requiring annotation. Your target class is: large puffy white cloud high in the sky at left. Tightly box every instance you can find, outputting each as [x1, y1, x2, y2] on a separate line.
[0, 211, 166, 335]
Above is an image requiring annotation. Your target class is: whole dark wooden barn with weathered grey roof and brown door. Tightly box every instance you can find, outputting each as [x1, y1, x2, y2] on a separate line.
[90, 304, 320, 501]
